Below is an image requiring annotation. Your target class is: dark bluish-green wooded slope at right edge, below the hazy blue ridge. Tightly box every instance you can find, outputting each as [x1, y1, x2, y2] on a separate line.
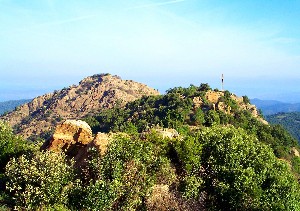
[265, 112, 300, 142]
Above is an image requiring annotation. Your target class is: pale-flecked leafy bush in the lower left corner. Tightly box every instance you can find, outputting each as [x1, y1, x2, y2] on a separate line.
[6, 151, 74, 209]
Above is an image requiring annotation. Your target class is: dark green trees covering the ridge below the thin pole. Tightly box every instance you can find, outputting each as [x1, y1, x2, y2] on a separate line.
[87, 84, 297, 158]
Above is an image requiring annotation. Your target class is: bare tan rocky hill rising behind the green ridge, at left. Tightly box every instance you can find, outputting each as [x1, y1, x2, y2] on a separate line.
[0, 74, 159, 138]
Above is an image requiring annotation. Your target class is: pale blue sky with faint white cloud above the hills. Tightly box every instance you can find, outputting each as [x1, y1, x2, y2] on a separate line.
[0, 0, 300, 102]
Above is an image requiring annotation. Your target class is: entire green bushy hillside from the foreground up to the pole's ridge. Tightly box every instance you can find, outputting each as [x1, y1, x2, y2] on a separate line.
[0, 84, 300, 210]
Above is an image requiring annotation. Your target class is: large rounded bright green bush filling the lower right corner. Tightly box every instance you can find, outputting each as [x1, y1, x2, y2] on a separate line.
[199, 127, 300, 210]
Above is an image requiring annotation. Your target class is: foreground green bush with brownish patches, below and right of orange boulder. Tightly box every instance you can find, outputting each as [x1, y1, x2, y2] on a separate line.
[69, 133, 174, 210]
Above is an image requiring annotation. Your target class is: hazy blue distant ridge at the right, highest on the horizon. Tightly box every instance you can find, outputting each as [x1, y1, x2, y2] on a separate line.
[251, 98, 300, 115]
